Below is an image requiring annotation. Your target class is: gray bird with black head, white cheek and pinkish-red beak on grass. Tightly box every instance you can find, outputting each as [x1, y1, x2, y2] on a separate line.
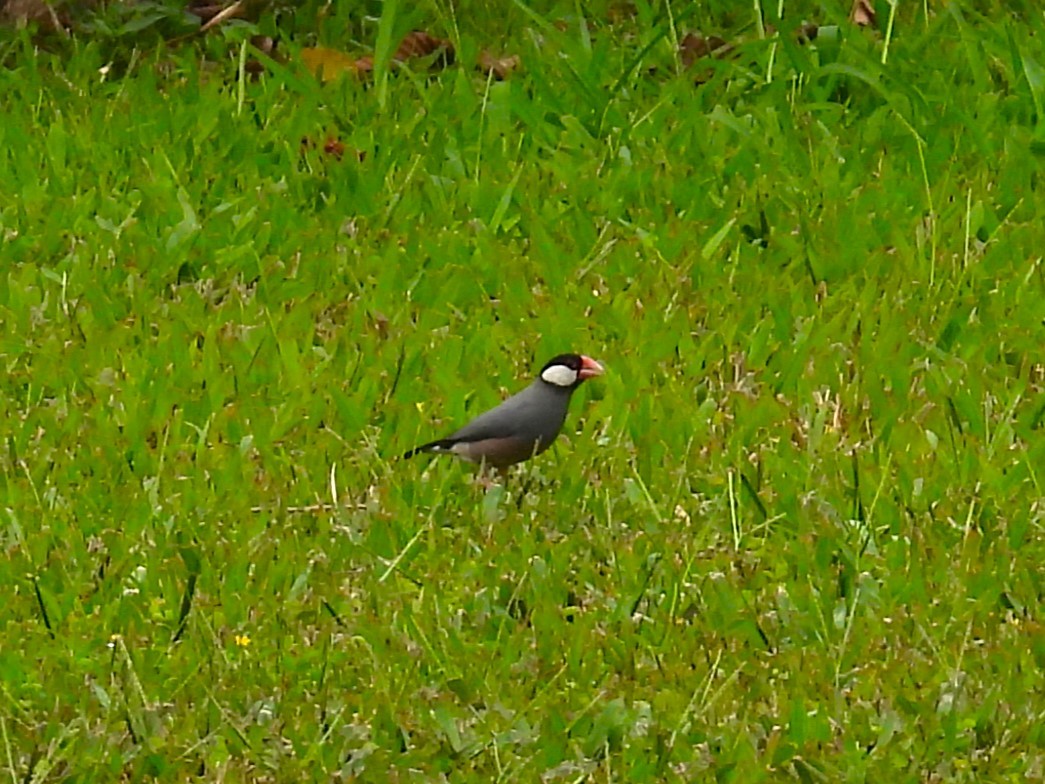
[403, 354, 603, 468]
